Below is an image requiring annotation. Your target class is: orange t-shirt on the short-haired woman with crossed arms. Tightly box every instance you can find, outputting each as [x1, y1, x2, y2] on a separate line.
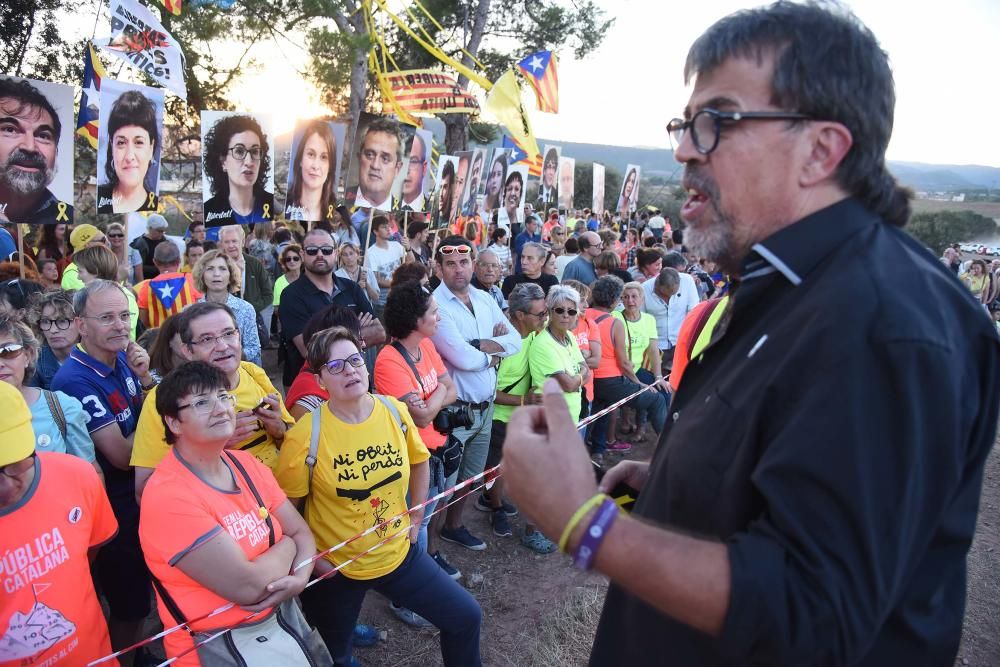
[139, 448, 286, 666]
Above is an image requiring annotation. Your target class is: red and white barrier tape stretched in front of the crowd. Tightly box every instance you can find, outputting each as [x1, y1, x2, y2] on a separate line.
[87, 384, 657, 667]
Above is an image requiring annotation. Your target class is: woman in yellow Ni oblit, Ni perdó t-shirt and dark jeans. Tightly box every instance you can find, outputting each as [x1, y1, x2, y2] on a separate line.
[277, 327, 482, 667]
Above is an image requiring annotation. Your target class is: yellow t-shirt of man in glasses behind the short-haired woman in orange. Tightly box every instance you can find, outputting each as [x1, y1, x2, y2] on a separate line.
[129, 361, 295, 470]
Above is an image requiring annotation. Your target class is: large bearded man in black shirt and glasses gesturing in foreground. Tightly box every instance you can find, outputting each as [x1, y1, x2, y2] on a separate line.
[503, 3, 1000, 665]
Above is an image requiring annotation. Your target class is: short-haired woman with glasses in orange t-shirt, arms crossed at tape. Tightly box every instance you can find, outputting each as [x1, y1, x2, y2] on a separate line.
[139, 361, 320, 666]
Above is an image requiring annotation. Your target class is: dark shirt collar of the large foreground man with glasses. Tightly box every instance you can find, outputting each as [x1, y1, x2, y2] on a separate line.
[740, 197, 879, 286]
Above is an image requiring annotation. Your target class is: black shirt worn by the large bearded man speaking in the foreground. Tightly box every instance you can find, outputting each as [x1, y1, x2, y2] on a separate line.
[591, 199, 1000, 666]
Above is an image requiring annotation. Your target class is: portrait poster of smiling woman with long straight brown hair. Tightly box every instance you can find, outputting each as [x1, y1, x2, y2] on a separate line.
[285, 118, 347, 222]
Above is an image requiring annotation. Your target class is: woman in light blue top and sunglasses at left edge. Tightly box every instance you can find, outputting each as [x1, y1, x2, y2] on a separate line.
[0, 315, 97, 477]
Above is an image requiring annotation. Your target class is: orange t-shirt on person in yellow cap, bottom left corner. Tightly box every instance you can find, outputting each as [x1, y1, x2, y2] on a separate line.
[0, 452, 118, 667]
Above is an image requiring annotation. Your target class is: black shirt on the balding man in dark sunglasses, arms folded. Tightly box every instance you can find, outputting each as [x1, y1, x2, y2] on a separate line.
[278, 272, 372, 387]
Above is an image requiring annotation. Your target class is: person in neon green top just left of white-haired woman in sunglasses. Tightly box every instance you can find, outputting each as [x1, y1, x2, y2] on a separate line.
[490, 283, 556, 554]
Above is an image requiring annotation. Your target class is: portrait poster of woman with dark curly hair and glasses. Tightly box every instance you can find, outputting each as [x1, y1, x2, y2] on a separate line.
[201, 111, 275, 228]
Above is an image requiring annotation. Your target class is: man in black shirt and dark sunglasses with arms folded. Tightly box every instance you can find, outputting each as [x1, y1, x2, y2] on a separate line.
[278, 228, 385, 389]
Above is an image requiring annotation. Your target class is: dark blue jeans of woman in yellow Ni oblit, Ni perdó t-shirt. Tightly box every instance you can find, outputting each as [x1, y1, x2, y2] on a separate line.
[300, 545, 482, 667]
